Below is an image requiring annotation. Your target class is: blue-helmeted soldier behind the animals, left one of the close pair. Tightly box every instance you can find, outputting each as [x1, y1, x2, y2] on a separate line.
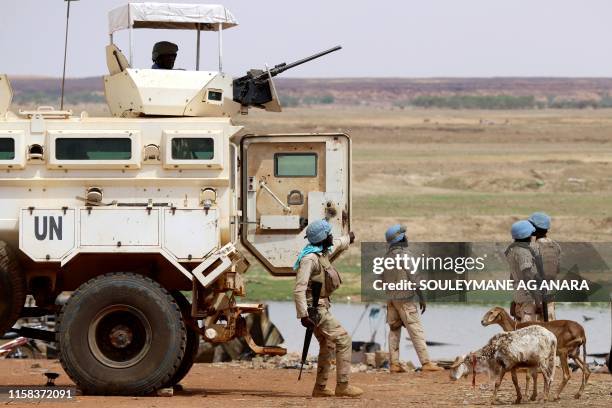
[505, 220, 540, 322]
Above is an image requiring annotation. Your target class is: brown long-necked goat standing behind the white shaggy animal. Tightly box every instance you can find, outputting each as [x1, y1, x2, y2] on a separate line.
[481, 306, 591, 399]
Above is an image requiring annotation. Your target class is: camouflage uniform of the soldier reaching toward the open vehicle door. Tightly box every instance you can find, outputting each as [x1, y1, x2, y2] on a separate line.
[293, 236, 352, 386]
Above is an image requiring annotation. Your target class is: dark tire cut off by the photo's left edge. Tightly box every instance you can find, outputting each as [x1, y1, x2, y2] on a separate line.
[0, 241, 26, 335]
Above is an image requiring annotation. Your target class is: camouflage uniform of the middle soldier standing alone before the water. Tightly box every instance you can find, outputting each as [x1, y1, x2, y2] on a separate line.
[383, 244, 430, 365]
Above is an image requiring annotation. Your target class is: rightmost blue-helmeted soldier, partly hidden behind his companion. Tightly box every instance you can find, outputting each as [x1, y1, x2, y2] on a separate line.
[528, 212, 562, 320]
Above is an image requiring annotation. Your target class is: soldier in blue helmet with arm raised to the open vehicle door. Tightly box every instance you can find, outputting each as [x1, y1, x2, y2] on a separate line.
[293, 220, 363, 397]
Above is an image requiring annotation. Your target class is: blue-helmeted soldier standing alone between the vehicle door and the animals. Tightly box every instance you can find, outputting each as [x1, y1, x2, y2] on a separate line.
[383, 224, 443, 373]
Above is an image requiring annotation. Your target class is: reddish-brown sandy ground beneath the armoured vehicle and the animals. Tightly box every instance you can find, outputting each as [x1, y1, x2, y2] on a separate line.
[0, 360, 612, 408]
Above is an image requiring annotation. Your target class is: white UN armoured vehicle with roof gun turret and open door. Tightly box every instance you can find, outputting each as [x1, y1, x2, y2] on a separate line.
[0, 3, 351, 394]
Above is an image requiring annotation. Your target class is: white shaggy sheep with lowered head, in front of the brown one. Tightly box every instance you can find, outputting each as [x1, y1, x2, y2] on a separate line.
[450, 326, 557, 404]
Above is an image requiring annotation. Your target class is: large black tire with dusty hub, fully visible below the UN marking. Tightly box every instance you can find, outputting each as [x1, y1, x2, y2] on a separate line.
[57, 273, 187, 395]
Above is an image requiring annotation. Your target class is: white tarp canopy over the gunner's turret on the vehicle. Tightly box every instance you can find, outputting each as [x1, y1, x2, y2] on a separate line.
[108, 3, 238, 34]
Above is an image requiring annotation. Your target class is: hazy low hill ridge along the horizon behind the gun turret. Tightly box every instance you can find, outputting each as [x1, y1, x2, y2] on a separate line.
[10, 77, 612, 109]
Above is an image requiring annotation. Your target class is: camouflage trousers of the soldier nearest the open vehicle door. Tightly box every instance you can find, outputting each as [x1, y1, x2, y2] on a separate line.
[314, 306, 352, 385]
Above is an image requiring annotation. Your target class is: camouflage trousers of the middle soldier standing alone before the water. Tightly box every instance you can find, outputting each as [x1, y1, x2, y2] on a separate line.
[387, 300, 429, 365]
